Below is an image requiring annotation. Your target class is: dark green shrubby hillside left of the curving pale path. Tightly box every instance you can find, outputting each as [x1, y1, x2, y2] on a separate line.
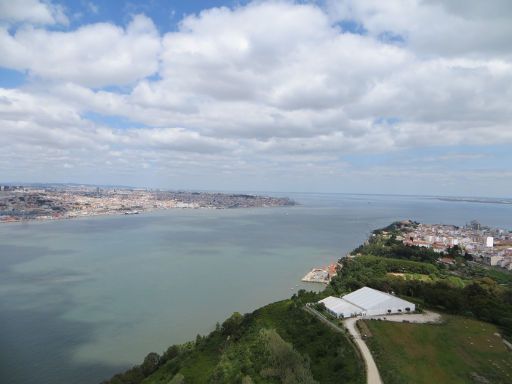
[105, 291, 364, 384]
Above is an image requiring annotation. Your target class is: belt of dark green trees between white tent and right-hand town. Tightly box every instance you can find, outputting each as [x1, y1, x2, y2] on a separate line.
[330, 223, 512, 338]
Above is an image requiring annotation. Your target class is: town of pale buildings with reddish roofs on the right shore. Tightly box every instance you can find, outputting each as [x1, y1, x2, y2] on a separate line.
[397, 221, 512, 270]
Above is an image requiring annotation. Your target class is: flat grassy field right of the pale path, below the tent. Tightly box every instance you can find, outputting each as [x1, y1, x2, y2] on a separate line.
[366, 316, 512, 384]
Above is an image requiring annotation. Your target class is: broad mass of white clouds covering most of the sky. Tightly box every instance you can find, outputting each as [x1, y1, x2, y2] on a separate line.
[0, 0, 512, 195]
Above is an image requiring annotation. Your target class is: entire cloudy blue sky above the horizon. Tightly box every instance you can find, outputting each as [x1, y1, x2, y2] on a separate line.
[0, 0, 512, 197]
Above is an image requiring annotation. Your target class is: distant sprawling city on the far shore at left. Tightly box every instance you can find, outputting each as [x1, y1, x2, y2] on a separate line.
[0, 185, 295, 222]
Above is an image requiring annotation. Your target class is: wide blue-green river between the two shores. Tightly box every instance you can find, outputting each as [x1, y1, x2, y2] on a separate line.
[0, 195, 512, 384]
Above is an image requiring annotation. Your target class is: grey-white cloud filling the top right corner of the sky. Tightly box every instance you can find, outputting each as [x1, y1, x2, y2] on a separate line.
[327, 0, 512, 58]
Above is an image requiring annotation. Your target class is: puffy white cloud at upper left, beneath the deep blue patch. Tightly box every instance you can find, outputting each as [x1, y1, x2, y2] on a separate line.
[0, 15, 160, 87]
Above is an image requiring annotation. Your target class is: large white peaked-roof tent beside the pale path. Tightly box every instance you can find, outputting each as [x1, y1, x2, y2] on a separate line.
[319, 287, 416, 318]
